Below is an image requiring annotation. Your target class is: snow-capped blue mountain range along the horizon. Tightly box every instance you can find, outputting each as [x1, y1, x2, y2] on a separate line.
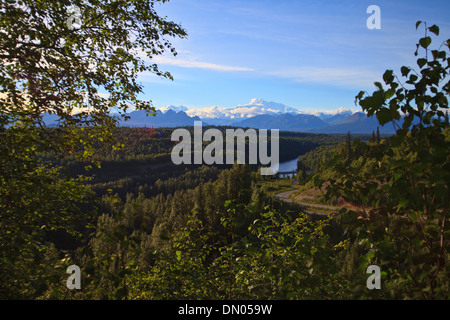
[44, 99, 395, 134]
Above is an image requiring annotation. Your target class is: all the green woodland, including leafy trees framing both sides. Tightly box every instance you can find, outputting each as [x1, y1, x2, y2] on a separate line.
[0, 0, 450, 300]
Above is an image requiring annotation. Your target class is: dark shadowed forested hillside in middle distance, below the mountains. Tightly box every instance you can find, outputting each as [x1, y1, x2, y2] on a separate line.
[61, 127, 345, 199]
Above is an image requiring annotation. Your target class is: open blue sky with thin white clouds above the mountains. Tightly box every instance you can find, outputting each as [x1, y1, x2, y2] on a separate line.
[134, 0, 450, 112]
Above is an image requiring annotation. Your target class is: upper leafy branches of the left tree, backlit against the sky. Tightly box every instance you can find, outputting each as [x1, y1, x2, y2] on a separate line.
[0, 0, 187, 154]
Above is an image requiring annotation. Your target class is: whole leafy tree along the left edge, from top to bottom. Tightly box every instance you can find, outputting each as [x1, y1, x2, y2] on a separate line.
[0, 0, 187, 298]
